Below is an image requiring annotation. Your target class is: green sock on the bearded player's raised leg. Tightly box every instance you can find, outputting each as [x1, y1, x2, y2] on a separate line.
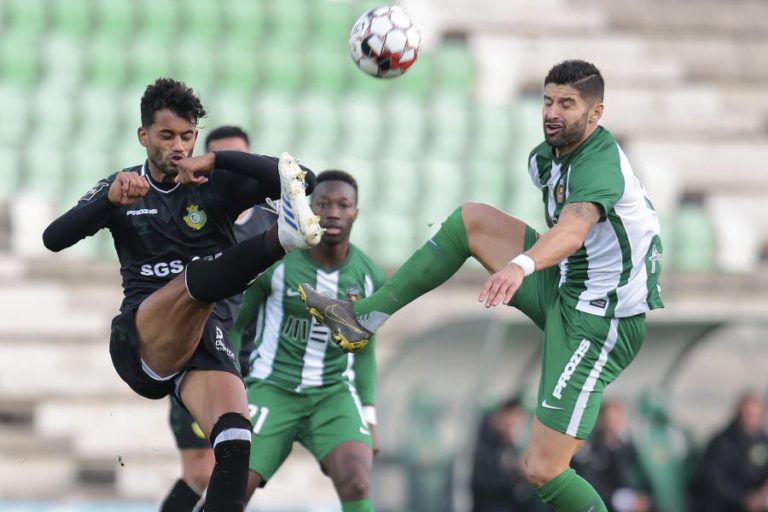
[354, 208, 470, 324]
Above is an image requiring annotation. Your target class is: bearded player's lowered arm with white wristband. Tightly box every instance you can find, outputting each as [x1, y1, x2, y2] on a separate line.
[479, 202, 602, 308]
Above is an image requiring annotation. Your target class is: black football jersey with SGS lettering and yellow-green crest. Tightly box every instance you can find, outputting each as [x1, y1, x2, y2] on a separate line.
[43, 155, 288, 316]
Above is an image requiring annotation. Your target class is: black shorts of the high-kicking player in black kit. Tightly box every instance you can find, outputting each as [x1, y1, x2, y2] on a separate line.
[109, 309, 242, 399]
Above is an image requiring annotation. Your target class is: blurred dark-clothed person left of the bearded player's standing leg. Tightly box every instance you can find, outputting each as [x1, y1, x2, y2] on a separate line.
[472, 398, 546, 512]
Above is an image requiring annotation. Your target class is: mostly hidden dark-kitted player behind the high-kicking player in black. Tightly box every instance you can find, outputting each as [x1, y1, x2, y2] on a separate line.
[160, 126, 277, 512]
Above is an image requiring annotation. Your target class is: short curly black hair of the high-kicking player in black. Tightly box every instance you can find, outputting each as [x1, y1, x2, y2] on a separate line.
[141, 78, 206, 128]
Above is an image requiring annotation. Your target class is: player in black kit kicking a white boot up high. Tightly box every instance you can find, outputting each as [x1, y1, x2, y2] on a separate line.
[43, 78, 322, 512]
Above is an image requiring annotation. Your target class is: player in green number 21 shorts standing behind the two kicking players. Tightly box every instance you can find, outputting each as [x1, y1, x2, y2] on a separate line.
[232, 171, 384, 512]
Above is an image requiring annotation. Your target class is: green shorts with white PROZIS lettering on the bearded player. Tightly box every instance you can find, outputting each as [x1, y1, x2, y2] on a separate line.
[509, 227, 646, 439]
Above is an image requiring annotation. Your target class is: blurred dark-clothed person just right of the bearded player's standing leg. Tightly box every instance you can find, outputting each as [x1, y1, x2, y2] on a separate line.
[572, 400, 651, 512]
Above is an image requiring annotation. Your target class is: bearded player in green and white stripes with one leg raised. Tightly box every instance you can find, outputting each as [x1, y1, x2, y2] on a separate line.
[299, 60, 663, 512]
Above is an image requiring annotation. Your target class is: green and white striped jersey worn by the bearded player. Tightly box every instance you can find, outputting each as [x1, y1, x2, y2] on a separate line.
[529, 126, 664, 318]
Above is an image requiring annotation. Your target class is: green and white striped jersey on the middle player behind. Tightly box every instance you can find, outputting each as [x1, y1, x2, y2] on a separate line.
[230, 245, 385, 404]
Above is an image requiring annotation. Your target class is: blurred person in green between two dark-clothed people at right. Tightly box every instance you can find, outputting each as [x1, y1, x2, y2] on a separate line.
[632, 388, 697, 512]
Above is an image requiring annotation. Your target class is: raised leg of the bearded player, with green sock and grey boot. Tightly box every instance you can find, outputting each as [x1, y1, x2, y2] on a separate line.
[299, 203, 526, 350]
